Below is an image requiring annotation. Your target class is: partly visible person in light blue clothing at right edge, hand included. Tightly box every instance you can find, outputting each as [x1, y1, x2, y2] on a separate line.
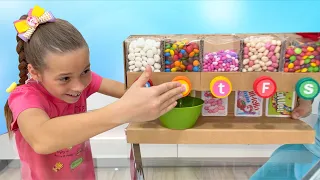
[250, 99, 320, 180]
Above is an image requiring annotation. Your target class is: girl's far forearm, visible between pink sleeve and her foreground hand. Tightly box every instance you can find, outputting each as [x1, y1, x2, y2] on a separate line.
[98, 78, 125, 98]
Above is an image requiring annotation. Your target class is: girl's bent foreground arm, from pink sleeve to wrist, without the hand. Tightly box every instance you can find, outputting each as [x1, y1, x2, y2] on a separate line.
[18, 101, 130, 154]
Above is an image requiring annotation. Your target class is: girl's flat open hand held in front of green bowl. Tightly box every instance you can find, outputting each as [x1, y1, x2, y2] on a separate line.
[120, 66, 184, 122]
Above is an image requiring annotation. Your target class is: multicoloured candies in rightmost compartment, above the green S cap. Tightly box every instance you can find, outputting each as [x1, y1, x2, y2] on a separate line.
[283, 42, 320, 73]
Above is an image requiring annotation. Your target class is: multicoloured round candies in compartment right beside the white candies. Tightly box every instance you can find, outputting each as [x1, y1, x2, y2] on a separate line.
[164, 40, 200, 72]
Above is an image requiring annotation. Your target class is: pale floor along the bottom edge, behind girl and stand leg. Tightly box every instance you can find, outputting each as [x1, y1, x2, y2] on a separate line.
[0, 167, 257, 180]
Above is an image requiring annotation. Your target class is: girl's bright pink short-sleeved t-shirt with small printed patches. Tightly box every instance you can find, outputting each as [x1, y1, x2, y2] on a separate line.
[8, 72, 102, 180]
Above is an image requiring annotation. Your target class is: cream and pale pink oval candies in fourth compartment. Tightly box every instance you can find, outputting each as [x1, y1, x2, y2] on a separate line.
[242, 36, 282, 72]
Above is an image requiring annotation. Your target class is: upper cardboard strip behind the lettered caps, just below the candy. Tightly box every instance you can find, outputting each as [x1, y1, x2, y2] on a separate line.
[126, 72, 320, 92]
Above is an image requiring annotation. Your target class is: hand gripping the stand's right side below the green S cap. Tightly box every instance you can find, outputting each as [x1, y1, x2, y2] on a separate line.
[291, 99, 312, 119]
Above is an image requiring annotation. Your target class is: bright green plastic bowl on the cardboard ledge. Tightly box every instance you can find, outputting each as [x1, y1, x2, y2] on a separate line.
[159, 96, 204, 130]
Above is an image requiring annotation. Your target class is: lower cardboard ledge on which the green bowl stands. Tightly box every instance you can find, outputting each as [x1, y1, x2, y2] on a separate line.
[126, 116, 315, 144]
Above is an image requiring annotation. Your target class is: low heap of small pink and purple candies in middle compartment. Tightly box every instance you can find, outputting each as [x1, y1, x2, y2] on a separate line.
[203, 50, 239, 72]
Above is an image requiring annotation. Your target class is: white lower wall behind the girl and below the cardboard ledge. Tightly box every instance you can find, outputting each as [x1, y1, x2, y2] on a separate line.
[0, 94, 320, 159]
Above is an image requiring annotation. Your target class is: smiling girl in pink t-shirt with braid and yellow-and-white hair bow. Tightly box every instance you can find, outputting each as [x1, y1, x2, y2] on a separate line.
[5, 6, 184, 180]
